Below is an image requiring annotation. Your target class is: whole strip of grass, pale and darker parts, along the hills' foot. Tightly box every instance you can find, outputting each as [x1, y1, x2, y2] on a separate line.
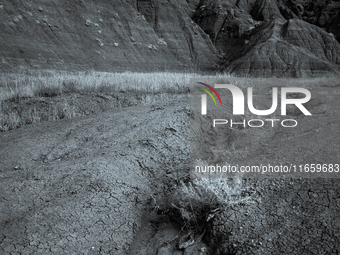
[0, 70, 340, 131]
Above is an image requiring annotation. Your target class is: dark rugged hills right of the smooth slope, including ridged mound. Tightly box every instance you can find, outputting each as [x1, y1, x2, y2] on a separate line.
[193, 0, 340, 77]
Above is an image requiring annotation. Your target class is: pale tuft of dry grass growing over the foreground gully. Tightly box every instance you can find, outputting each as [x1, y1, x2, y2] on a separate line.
[167, 169, 254, 232]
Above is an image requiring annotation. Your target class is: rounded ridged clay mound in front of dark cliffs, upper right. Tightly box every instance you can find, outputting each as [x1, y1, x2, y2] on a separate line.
[226, 19, 340, 77]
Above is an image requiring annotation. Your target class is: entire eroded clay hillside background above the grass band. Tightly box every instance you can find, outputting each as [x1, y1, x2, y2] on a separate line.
[0, 0, 340, 77]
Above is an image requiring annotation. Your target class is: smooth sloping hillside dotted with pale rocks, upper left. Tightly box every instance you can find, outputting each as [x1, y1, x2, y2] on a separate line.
[0, 0, 217, 71]
